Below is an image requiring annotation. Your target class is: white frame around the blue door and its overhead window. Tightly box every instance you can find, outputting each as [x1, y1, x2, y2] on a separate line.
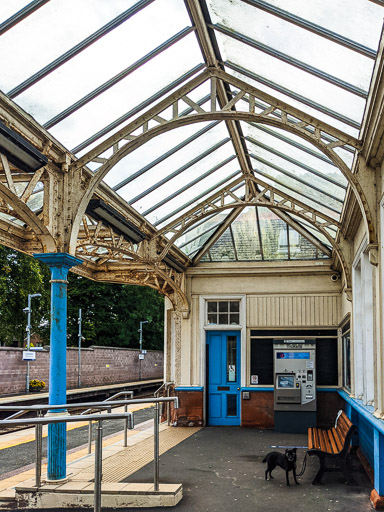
[199, 294, 247, 425]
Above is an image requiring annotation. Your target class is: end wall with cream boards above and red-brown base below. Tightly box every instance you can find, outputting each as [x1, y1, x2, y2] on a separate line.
[165, 261, 344, 428]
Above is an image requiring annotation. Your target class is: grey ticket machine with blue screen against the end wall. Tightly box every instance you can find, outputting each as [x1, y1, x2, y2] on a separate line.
[273, 339, 317, 433]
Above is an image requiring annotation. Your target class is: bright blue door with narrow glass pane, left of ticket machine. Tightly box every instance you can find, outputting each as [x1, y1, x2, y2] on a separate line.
[207, 331, 240, 425]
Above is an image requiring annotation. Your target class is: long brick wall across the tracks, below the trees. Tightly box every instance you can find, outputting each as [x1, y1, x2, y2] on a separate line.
[0, 347, 163, 395]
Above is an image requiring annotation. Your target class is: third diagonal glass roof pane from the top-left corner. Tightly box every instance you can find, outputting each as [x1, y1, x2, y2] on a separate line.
[13, 0, 193, 123]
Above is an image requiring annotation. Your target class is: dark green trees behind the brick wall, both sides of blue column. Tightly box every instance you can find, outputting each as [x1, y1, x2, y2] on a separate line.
[0, 246, 164, 350]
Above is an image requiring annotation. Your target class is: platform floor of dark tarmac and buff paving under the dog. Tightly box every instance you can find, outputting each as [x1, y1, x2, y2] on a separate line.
[0, 421, 372, 512]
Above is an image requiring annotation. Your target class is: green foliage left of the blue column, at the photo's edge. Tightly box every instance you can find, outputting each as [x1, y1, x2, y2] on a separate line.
[0, 246, 50, 345]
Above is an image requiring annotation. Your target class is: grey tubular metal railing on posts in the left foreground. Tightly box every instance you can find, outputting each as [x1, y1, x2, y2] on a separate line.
[0, 397, 179, 512]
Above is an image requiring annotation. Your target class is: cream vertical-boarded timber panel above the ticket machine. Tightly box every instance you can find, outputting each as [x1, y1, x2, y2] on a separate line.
[247, 294, 340, 327]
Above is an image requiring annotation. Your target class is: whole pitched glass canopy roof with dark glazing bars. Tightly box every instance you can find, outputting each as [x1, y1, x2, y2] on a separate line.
[0, 0, 384, 264]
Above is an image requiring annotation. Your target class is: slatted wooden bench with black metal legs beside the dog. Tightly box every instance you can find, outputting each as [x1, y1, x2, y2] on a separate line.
[308, 410, 356, 485]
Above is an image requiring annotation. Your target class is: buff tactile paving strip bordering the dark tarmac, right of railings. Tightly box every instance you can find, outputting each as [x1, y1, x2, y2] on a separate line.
[103, 427, 201, 482]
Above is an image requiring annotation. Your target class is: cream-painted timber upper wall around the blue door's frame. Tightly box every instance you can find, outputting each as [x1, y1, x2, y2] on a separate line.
[167, 262, 342, 386]
